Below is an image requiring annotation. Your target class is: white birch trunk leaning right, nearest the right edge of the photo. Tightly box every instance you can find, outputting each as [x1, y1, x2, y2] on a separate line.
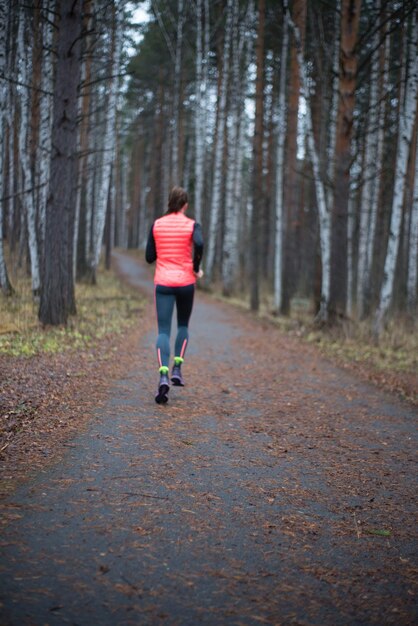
[373, 14, 418, 337]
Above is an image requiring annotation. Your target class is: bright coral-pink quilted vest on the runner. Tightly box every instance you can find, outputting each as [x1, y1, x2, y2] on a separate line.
[152, 213, 196, 287]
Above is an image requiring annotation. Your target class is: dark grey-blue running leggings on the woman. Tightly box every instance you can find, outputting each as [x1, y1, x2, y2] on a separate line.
[155, 284, 195, 367]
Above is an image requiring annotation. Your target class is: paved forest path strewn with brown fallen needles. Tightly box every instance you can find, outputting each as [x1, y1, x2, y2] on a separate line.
[0, 254, 418, 626]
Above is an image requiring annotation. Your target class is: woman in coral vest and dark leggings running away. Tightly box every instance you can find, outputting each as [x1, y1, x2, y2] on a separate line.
[145, 187, 203, 404]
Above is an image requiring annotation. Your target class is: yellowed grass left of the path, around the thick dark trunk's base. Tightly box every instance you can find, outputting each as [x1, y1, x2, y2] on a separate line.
[0, 269, 143, 357]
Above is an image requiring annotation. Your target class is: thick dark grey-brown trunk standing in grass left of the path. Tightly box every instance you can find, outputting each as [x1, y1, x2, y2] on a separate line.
[39, 0, 82, 325]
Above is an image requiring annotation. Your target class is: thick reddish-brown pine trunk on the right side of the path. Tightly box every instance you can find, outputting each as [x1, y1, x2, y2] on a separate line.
[329, 0, 361, 321]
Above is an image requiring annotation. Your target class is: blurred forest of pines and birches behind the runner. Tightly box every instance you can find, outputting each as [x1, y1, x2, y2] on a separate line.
[0, 0, 418, 336]
